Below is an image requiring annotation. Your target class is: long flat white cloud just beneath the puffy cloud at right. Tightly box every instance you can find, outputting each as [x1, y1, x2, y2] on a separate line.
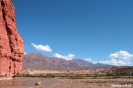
[100, 59, 130, 66]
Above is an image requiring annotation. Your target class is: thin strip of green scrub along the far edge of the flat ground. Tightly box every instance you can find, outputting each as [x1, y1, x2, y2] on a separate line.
[15, 73, 133, 79]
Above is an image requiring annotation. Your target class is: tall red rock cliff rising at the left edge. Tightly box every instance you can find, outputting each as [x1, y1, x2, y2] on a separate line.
[0, 0, 24, 76]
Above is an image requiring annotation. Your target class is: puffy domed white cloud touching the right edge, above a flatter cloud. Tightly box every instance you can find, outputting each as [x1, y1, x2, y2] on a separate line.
[109, 50, 133, 60]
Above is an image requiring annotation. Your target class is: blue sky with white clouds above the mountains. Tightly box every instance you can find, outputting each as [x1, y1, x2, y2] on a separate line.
[12, 0, 133, 65]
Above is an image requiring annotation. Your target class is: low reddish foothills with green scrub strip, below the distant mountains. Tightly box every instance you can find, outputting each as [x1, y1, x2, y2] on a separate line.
[16, 66, 133, 79]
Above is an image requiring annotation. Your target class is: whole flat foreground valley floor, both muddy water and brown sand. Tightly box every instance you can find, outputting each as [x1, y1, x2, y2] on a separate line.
[0, 78, 133, 88]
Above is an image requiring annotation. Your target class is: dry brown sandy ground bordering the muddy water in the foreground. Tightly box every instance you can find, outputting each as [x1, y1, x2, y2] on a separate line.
[0, 79, 133, 88]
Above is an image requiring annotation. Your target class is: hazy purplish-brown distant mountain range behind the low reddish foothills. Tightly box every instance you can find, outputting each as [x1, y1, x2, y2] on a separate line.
[22, 53, 112, 70]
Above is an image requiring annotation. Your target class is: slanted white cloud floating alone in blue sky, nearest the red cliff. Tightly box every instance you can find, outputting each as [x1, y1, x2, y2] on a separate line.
[31, 43, 52, 52]
